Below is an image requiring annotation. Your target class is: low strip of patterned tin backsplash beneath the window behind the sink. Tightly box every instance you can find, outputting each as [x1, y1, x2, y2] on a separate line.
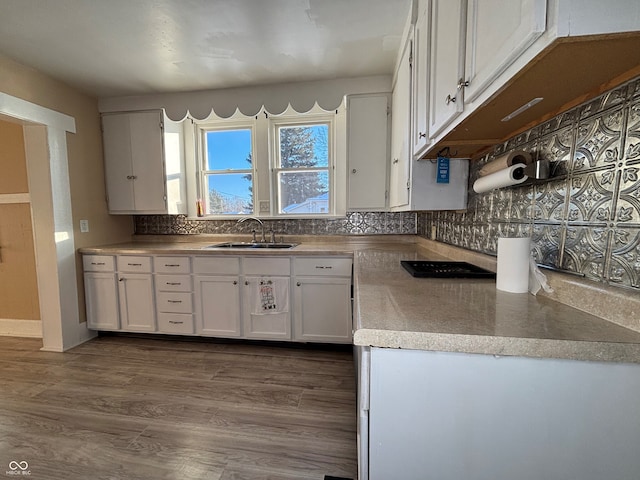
[134, 212, 417, 235]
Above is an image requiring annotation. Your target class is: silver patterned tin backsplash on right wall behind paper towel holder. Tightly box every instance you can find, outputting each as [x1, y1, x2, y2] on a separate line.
[418, 79, 640, 289]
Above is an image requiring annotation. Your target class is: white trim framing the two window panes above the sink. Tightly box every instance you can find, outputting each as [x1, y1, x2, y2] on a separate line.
[185, 105, 347, 220]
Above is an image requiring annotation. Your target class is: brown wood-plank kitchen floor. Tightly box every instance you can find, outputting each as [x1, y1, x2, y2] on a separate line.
[0, 336, 357, 480]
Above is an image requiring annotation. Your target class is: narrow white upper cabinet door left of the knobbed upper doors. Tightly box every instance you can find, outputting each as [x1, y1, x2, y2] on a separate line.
[411, 0, 431, 157]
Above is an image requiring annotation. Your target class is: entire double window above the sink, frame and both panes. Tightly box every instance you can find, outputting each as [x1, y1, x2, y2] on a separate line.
[187, 106, 346, 218]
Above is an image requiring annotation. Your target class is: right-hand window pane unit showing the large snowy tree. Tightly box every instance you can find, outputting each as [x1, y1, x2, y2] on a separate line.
[274, 123, 331, 215]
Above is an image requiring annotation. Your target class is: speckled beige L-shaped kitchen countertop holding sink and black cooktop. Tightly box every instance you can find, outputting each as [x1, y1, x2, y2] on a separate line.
[80, 236, 640, 363]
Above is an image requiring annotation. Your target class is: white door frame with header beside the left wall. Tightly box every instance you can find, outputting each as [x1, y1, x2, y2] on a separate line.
[0, 92, 95, 352]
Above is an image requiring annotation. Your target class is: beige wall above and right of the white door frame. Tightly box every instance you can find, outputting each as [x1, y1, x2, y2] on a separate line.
[0, 55, 133, 319]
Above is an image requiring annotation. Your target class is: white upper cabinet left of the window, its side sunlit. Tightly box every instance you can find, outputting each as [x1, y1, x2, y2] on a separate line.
[102, 110, 186, 214]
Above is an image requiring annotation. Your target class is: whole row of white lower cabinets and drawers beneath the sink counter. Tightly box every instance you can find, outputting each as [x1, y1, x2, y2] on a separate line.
[83, 255, 353, 343]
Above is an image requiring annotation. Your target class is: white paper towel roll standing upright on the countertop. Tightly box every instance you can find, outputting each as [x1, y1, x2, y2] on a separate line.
[496, 237, 531, 293]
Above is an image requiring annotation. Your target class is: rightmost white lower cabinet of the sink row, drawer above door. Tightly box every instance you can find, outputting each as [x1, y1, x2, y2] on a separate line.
[294, 257, 353, 343]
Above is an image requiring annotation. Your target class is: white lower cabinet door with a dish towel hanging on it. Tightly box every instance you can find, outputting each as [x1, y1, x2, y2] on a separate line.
[242, 276, 291, 340]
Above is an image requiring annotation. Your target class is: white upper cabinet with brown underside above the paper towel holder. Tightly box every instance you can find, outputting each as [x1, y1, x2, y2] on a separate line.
[420, 0, 640, 158]
